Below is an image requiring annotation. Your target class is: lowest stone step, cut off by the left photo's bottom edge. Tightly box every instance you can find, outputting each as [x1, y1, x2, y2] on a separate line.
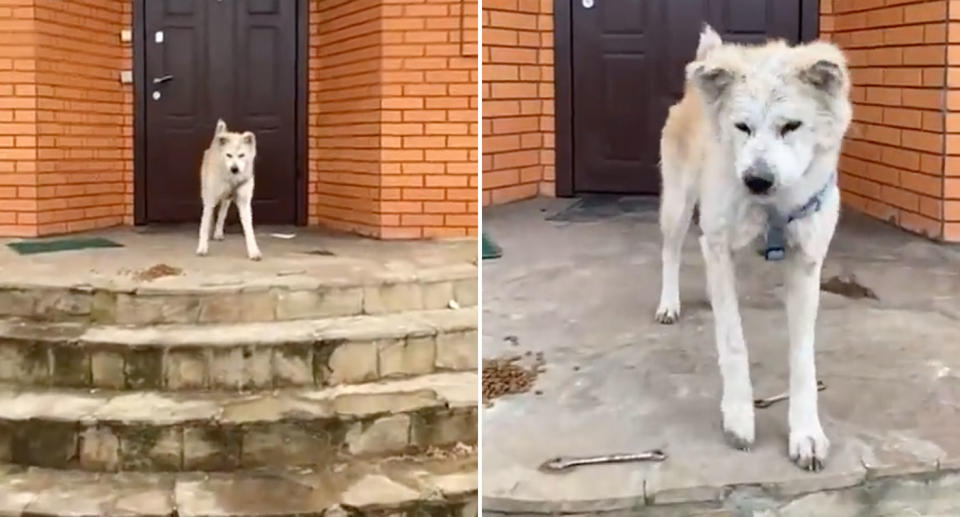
[0, 455, 477, 517]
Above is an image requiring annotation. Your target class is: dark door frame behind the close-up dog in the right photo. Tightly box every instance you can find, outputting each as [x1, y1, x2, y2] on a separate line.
[553, 0, 820, 197]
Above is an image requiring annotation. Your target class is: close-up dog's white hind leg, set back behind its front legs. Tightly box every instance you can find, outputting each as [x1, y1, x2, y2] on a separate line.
[655, 177, 696, 325]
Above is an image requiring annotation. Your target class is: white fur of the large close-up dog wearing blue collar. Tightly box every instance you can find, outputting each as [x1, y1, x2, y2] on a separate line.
[656, 26, 852, 470]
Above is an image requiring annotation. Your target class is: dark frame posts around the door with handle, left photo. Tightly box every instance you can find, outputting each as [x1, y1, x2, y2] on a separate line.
[133, 0, 310, 226]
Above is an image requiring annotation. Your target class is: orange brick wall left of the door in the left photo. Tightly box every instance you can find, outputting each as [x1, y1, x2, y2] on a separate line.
[0, 0, 133, 236]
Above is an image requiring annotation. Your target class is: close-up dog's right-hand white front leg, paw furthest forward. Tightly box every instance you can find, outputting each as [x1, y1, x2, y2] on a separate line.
[785, 250, 830, 470]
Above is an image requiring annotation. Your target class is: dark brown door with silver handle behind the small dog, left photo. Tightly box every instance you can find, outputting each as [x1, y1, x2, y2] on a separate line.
[142, 0, 299, 224]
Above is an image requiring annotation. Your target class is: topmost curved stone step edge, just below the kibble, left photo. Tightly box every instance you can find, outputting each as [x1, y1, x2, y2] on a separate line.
[0, 264, 477, 325]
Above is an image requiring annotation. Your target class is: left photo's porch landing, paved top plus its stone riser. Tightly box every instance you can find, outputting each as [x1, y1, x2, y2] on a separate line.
[0, 227, 477, 324]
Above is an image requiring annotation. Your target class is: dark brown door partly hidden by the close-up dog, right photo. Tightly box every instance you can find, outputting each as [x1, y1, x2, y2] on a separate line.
[570, 0, 800, 194]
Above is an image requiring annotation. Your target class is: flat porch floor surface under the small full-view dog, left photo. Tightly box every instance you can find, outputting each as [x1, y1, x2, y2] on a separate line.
[0, 225, 477, 291]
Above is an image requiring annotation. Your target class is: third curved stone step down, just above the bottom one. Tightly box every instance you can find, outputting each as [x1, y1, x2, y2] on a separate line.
[0, 372, 478, 472]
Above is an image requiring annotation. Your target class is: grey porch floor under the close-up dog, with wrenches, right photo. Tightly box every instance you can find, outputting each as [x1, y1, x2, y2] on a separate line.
[481, 199, 960, 517]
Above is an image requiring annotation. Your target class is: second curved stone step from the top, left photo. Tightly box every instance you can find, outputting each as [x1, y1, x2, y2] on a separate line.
[0, 308, 477, 391]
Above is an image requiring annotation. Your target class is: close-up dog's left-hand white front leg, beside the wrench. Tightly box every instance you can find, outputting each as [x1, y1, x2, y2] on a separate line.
[700, 235, 754, 450]
